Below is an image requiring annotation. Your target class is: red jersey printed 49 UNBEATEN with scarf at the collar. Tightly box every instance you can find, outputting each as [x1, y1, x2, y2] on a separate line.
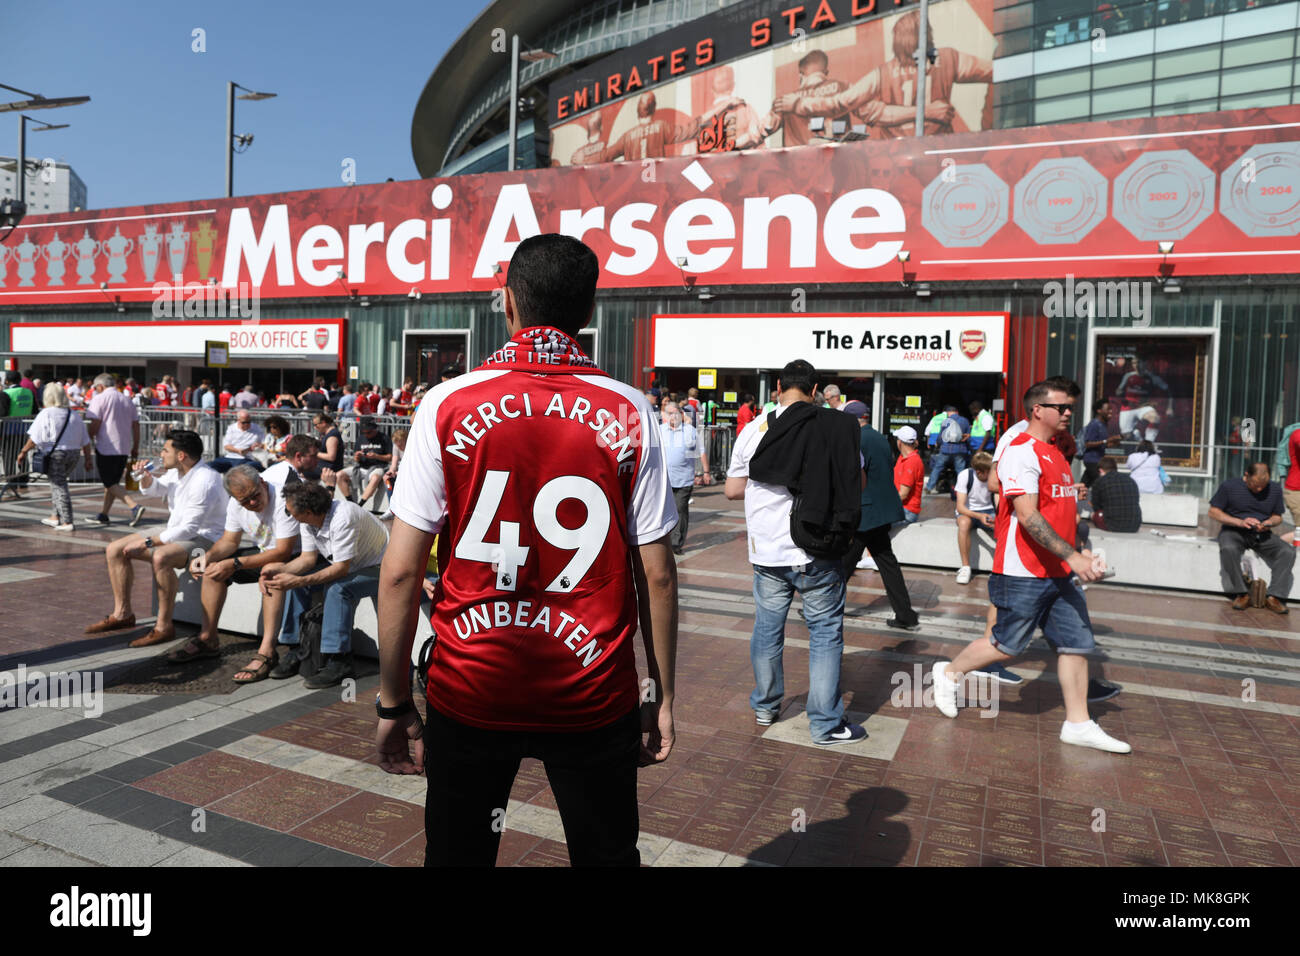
[393, 326, 677, 731]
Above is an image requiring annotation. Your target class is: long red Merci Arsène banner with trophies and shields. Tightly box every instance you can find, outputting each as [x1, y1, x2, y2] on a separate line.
[0, 107, 1300, 303]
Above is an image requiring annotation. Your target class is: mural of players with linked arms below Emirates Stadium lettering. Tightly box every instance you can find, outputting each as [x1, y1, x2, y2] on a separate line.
[551, 0, 996, 165]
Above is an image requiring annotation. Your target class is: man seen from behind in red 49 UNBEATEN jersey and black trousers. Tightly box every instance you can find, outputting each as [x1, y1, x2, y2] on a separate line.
[376, 234, 677, 866]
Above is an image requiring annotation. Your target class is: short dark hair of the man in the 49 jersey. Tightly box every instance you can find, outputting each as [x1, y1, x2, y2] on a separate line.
[506, 233, 601, 336]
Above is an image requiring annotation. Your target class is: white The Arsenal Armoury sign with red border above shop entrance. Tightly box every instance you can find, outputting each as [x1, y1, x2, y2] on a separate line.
[653, 312, 1009, 372]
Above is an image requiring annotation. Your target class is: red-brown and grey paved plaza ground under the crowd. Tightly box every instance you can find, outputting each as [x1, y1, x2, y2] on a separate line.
[0, 486, 1300, 866]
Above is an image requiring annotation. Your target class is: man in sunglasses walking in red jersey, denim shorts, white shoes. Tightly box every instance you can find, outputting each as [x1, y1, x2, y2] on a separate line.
[933, 381, 1132, 753]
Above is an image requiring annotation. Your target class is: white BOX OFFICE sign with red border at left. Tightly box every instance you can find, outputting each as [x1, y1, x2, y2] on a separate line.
[9, 319, 343, 365]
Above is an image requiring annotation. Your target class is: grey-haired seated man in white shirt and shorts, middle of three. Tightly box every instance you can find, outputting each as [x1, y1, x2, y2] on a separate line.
[168, 464, 300, 684]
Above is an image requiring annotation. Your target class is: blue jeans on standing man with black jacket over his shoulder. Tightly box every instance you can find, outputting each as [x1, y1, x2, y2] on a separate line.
[749, 559, 846, 740]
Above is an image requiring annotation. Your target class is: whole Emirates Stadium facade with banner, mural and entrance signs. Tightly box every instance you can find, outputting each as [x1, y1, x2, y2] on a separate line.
[0, 0, 1300, 493]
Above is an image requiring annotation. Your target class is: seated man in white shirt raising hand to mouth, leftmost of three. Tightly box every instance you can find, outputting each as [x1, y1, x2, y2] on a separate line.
[86, 428, 228, 648]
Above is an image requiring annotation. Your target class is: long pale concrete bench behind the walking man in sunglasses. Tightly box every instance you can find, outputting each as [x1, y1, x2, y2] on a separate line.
[893, 515, 1300, 601]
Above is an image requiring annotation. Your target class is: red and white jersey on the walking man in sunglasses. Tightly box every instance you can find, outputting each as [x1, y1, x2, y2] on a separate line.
[993, 432, 1079, 578]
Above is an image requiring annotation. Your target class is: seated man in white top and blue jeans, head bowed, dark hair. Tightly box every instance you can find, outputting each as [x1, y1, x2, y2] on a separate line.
[261, 481, 389, 688]
